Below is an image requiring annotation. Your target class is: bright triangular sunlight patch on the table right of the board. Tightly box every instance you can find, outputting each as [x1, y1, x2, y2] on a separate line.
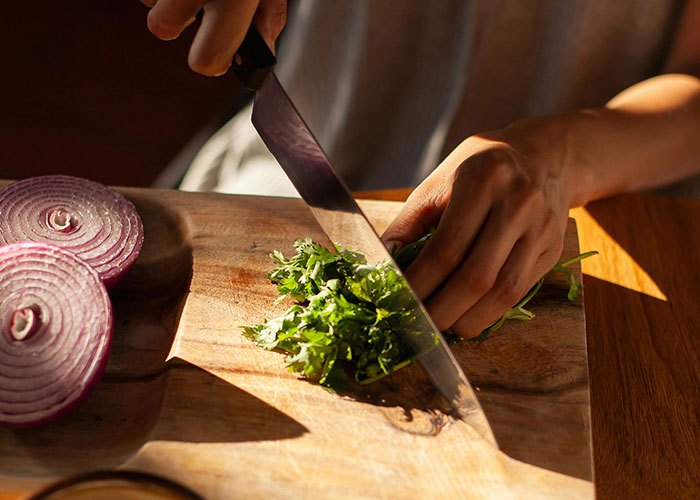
[569, 207, 668, 301]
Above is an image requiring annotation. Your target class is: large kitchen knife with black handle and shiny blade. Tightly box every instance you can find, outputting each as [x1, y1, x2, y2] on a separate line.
[232, 25, 497, 446]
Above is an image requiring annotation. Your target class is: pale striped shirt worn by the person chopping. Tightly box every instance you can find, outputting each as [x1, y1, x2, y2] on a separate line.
[181, 0, 683, 199]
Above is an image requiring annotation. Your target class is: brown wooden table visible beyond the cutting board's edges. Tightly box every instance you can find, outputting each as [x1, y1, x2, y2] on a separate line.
[0, 188, 700, 500]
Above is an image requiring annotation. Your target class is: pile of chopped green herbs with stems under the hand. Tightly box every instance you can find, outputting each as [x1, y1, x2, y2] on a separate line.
[242, 233, 596, 391]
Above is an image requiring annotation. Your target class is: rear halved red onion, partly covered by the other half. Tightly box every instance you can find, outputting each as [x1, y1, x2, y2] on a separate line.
[0, 175, 143, 290]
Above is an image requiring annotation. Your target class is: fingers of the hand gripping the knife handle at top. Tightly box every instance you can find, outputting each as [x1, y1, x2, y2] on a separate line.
[141, 0, 287, 76]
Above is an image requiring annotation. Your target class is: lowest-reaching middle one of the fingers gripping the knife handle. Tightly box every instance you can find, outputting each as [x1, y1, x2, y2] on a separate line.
[188, 0, 258, 76]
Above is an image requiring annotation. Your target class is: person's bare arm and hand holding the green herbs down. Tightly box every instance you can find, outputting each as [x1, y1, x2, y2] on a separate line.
[384, 2, 700, 337]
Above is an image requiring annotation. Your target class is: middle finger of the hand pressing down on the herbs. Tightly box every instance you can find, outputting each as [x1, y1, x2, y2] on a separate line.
[426, 210, 522, 330]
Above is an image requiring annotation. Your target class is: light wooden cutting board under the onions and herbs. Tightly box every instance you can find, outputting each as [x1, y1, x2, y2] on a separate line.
[0, 189, 594, 500]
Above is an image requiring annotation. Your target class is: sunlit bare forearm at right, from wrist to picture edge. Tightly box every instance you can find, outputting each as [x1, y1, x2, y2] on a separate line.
[506, 75, 700, 207]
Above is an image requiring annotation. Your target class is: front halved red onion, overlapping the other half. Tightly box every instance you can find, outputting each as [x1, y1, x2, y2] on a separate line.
[0, 242, 112, 427]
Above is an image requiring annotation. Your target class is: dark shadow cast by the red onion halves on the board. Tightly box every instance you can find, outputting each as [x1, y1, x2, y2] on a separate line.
[0, 192, 306, 482]
